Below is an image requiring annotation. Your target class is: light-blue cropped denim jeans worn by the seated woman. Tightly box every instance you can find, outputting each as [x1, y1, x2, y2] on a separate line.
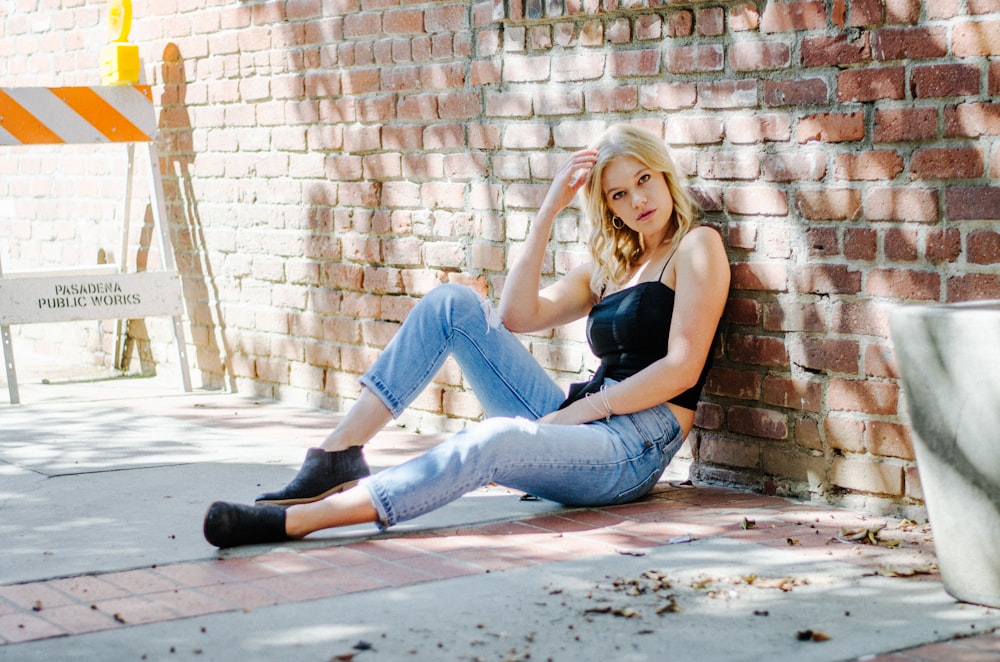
[361, 285, 684, 526]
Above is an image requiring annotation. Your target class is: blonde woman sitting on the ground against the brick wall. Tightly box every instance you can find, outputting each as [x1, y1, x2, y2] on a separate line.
[204, 125, 729, 547]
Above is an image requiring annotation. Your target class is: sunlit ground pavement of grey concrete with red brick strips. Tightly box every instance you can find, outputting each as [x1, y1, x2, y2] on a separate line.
[0, 370, 1000, 662]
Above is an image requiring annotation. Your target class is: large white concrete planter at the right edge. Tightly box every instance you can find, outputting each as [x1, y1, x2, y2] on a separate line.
[889, 301, 1000, 607]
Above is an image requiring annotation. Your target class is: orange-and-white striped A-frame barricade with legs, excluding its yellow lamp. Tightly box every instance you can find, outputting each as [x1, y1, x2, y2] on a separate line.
[0, 85, 191, 404]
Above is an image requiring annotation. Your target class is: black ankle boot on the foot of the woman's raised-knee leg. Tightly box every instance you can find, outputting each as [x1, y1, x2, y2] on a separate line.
[255, 446, 371, 506]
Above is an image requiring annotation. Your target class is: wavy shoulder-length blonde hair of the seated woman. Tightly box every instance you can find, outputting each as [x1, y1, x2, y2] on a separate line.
[583, 124, 700, 293]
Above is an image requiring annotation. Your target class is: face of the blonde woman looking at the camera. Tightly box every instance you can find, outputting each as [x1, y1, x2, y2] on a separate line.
[601, 156, 674, 245]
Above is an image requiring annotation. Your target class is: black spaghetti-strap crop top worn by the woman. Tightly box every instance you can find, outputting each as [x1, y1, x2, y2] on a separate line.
[560, 275, 712, 409]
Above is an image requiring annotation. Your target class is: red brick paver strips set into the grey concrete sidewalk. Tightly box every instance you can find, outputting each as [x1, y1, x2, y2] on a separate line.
[0, 484, 1000, 662]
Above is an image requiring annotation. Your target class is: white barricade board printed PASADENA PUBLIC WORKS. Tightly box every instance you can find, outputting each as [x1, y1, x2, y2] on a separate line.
[0, 271, 183, 324]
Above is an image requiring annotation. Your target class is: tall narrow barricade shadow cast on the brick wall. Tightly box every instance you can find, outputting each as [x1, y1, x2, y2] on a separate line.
[158, 43, 236, 391]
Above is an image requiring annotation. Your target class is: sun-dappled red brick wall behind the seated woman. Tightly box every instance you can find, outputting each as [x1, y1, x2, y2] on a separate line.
[0, 0, 1000, 508]
